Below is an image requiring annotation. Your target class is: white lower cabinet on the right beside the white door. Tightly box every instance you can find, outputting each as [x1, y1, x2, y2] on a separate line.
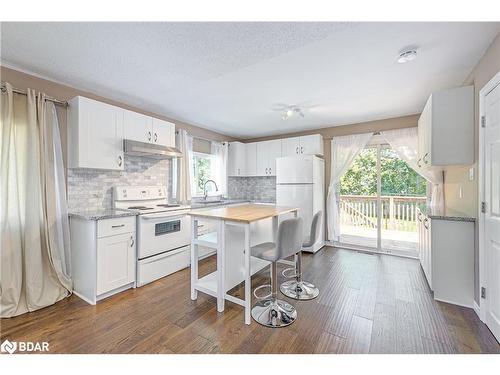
[417, 210, 475, 307]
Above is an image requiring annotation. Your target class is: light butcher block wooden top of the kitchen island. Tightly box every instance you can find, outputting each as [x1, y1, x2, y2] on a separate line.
[189, 204, 298, 223]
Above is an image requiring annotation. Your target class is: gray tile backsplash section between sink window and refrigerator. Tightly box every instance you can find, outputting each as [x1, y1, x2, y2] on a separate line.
[228, 176, 276, 203]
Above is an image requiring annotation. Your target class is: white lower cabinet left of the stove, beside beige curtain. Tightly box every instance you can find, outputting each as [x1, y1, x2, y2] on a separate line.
[70, 216, 136, 304]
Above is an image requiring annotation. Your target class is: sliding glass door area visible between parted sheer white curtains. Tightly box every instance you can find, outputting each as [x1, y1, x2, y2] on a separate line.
[337, 143, 426, 257]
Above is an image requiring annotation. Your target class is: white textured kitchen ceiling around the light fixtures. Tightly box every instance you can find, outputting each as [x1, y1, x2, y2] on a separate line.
[1, 22, 500, 138]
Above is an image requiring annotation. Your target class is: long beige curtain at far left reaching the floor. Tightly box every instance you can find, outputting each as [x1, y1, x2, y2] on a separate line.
[0, 84, 72, 318]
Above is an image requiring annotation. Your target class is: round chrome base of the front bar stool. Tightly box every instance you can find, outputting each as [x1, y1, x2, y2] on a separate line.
[252, 299, 297, 328]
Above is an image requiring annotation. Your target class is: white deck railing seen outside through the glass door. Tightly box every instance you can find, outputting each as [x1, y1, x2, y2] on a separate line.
[339, 195, 426, 231]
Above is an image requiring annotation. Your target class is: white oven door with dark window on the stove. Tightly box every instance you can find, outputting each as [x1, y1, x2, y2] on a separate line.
[137, 210, 191, 259]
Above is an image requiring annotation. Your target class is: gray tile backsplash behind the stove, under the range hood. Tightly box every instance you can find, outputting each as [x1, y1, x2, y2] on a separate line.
[67, 155, 172, 211]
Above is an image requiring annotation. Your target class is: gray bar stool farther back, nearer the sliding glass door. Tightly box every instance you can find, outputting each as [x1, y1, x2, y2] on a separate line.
[280, 211, 323, 300]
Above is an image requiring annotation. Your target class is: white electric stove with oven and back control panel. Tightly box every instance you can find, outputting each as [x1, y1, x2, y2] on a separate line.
[113, 186, 191, 287]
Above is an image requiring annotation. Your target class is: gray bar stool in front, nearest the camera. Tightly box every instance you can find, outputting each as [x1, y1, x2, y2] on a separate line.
[251, 218, 302, 328]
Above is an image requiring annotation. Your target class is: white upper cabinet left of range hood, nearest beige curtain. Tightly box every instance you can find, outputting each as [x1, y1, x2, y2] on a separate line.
[68, 96, 124, 170]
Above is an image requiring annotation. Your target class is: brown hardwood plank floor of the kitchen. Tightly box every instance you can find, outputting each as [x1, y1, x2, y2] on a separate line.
[0, 247, 500, 353]
